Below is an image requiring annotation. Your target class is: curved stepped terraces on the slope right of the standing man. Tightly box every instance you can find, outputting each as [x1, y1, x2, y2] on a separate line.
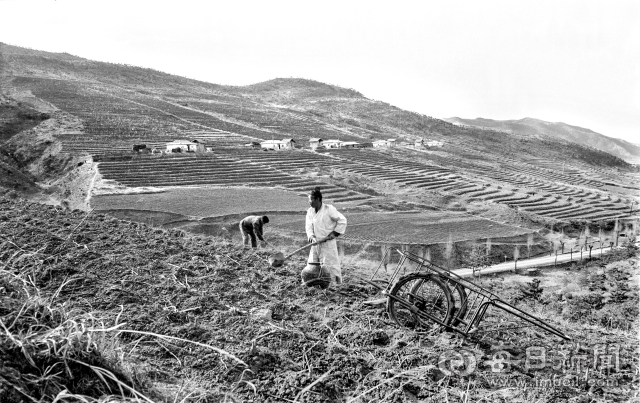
[306, 150, 631, 221]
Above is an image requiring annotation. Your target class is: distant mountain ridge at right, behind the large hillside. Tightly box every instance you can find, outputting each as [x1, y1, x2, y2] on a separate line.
[443, 117, 640, 164]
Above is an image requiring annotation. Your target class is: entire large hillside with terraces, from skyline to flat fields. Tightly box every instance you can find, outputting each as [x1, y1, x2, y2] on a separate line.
[0, 44, 638, 229]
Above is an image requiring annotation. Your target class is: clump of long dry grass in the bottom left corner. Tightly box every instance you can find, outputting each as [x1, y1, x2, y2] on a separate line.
[0, 270, 151, 402]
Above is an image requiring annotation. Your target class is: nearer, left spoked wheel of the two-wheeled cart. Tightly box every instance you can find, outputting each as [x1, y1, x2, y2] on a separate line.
[387, 273, 454, 332]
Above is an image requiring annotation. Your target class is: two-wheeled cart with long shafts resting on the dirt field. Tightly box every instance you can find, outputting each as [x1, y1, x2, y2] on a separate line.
[362, 248, 570, 340]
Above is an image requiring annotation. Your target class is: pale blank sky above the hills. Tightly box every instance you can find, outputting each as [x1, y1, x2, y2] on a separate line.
[0, 0, 640, 143]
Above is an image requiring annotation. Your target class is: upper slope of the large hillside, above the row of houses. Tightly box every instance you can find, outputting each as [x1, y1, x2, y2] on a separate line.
[0, 44, 624, 166]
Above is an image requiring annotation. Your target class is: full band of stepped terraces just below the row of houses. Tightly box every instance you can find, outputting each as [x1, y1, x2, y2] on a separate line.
[90, 140, 631, 221]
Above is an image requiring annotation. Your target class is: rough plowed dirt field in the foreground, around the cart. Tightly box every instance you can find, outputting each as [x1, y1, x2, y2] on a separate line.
[0, 199, 638, 402]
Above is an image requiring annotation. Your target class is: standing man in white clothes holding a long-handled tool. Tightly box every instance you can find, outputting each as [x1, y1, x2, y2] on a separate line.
[305, 187, 347, 284]
